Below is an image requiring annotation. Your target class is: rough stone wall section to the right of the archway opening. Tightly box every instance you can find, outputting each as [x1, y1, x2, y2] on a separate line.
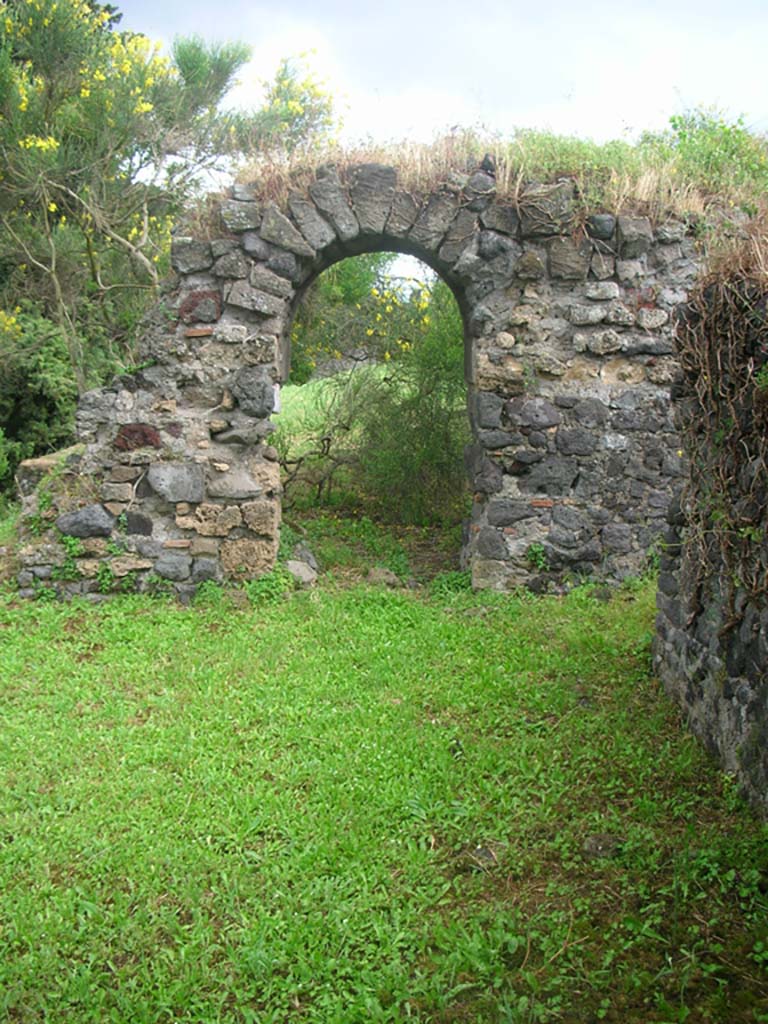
[460, 194, 696, 589]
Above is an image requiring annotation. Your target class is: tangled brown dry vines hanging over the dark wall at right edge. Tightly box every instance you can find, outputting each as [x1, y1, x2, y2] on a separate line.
[678, 213, 768, 627]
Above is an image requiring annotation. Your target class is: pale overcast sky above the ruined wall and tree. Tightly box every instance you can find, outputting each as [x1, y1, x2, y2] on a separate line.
[117, 0, 768, 141]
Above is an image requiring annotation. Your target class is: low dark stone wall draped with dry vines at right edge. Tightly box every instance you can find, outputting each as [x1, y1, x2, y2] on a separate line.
[653, 259, 768, 814]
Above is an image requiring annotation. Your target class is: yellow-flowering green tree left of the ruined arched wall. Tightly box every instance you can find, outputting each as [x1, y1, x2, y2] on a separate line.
[0, 0, 337, 495]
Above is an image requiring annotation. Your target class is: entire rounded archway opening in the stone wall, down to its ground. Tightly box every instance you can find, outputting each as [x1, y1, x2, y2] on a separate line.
[272, 252, 471, 580]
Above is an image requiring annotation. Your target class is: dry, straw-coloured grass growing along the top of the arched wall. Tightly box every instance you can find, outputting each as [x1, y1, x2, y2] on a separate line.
[238, 123, 768, 221]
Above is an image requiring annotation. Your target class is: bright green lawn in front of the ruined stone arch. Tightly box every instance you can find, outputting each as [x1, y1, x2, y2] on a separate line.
[0, 584, 768, 1024]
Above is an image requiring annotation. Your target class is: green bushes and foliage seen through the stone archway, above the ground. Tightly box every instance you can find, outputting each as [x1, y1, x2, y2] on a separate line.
[275, 257, 469, 523]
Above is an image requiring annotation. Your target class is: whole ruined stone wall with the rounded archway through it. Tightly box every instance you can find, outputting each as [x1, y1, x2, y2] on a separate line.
[18, 165, 695, 596]
